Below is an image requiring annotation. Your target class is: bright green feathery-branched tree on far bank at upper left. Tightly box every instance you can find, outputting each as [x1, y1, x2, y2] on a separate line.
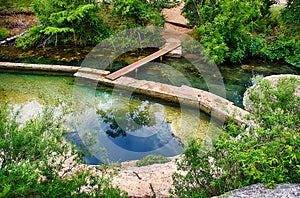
[17, 0, 112, 48]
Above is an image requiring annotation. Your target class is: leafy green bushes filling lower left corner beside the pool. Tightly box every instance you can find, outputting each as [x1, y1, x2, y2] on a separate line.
[0, 104, 124, 197]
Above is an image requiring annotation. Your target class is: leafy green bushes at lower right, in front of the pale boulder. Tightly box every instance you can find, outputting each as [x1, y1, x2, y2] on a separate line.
[172, 78, 300, 197]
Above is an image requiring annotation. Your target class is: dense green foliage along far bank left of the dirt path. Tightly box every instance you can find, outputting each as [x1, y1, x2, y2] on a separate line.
[17, 0, 163, 48]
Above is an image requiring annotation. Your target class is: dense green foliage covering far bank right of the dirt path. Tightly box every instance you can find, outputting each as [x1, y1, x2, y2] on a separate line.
[183, 0, 300, 66]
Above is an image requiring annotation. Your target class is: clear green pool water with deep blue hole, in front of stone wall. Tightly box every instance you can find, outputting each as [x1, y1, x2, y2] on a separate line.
[0, 73, 216, 164]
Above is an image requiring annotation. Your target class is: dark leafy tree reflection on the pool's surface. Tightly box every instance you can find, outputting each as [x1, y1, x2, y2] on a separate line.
[97, 102, 154, 138]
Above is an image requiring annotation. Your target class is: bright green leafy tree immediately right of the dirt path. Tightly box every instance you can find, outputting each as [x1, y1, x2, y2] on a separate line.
[183, 0, 276, 63]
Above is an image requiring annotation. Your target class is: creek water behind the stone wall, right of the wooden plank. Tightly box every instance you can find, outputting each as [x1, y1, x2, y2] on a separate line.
[128, 58, 300, 107]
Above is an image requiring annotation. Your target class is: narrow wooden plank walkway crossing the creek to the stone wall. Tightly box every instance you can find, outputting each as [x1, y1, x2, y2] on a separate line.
[106, 42, 181, 80]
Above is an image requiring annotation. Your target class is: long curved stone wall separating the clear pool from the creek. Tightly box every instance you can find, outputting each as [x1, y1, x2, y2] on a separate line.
[0, 62, 248, 124]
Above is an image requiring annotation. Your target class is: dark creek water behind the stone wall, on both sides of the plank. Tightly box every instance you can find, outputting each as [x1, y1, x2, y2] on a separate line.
[0, 46, 300, 107]
